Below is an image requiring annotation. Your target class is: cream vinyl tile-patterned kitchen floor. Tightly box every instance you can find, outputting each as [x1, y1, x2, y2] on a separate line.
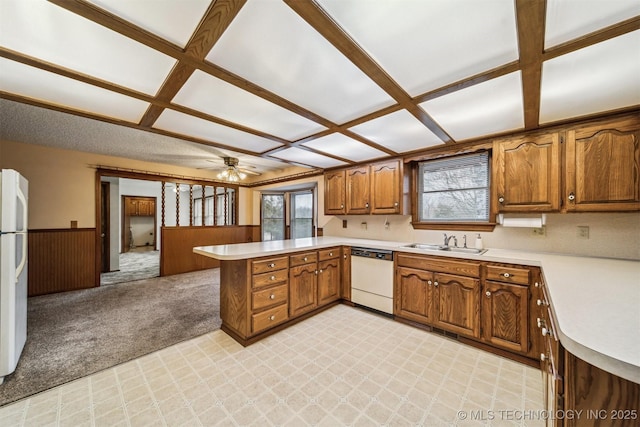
[0, 305, 544, 427]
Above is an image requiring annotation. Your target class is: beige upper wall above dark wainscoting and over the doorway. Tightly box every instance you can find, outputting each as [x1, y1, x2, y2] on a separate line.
[0, 141, 225, 229]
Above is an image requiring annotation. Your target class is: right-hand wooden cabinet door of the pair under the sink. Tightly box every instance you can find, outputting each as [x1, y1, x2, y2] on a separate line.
[433, 273, 480, 338]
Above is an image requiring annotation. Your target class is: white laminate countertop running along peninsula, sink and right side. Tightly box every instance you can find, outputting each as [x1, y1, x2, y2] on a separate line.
[193, 236, 640, 384]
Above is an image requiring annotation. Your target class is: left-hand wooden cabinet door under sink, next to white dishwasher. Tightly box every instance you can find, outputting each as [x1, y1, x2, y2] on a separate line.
[393, 267, 434, 324]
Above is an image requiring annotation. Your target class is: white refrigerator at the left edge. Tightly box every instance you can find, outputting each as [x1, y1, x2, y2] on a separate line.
[0, 169, 29, 384]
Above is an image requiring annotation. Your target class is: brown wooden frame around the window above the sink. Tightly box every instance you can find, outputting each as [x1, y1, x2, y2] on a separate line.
[410, 150, 496, 231]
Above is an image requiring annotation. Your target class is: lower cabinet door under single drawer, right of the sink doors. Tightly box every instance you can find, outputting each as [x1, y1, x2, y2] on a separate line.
[482, 281, 529, 353]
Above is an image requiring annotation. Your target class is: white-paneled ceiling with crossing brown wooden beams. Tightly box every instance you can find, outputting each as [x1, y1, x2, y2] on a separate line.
[0, 0, 640, 177]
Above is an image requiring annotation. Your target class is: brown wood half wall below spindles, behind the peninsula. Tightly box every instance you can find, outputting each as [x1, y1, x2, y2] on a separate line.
[160, 225, 260, 276]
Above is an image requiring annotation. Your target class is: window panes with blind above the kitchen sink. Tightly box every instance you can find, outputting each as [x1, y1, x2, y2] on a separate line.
[418, 152, 489, 222]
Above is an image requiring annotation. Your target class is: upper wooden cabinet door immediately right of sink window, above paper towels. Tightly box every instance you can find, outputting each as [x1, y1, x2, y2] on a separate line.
[493, 133, 560, 212]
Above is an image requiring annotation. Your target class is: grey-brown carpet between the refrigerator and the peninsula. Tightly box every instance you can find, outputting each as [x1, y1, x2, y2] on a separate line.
[0, 269, 221, 405]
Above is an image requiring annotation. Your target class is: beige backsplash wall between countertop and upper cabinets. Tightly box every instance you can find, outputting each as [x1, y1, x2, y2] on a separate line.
[324, 212, 640, 260]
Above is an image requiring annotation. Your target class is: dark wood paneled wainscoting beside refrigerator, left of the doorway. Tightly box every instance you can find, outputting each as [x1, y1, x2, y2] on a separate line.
[28, 228, 99, 297]
